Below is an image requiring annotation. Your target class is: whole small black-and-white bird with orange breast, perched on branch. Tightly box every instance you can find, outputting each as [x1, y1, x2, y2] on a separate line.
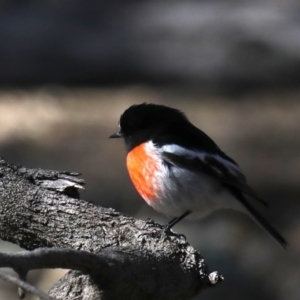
[110, 103, 288, 248]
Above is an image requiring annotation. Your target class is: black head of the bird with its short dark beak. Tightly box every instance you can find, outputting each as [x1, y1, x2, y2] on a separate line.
[110, 103, 188, 151]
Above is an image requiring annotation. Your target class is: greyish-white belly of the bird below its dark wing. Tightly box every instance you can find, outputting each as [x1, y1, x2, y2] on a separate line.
[145, 159, 245, 219]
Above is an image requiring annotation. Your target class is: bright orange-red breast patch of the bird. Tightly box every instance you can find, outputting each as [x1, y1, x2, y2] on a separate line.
[127, 143, 158, 201]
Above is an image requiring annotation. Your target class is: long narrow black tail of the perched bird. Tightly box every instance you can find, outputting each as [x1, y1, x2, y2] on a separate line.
[233, 190, 288, 249]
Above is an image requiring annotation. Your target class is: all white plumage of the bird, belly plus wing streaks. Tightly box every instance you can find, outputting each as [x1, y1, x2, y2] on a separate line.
[145, 141, 244, 218]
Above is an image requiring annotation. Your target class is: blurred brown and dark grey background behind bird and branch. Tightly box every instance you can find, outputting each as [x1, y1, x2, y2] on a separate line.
[0, 0, 300, 300]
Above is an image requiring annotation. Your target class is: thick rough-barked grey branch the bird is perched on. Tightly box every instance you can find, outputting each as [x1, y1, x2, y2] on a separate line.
[0, 160, 222, 299]
